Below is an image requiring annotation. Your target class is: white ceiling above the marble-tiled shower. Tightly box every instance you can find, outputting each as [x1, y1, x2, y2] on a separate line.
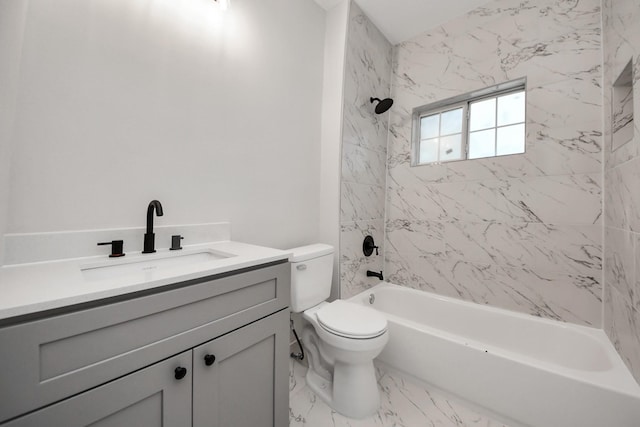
[315, 0, 488, 44]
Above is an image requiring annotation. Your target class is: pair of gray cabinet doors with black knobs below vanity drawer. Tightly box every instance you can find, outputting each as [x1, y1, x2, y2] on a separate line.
[3, 310, 289, 427]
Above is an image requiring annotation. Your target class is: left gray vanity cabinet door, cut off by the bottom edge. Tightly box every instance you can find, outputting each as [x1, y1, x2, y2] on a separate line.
[3, 351, 192, 427]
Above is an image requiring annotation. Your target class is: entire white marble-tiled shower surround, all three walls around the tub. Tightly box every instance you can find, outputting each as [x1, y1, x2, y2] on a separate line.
[340, 0, 640, 381]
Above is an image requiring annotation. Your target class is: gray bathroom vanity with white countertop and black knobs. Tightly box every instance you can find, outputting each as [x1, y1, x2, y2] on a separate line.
[0, 242, 290, 427]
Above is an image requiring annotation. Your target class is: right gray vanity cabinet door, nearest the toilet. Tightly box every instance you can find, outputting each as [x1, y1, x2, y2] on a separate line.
[193, 310, 289, 427]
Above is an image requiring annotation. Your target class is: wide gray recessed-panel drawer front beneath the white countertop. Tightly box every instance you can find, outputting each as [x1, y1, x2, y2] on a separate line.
[0, 263, 290, 423]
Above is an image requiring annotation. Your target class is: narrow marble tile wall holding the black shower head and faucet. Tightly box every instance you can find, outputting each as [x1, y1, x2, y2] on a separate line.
[340, 2, 392, 298]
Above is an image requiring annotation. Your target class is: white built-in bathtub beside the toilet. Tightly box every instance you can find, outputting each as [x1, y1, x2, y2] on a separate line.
[350, 283, 640, 427]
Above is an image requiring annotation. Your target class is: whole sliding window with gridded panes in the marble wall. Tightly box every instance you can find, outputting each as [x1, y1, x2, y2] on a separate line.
[412, 79, 526, 166]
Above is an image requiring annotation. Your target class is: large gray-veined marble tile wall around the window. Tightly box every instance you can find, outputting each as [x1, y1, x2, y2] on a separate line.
[384, 0, 604, 327]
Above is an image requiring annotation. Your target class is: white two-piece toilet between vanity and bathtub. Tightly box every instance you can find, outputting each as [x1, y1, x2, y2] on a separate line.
[289, 244, 389, 418]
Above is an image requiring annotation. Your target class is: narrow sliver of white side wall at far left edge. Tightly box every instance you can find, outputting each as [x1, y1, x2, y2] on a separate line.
[0, 0, 27, 265]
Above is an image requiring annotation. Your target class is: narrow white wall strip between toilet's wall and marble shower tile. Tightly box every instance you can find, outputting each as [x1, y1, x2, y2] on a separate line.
[318, 0, 349, 298]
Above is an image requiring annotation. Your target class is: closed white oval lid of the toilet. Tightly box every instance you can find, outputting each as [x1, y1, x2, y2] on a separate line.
[316, 300, 387, 338]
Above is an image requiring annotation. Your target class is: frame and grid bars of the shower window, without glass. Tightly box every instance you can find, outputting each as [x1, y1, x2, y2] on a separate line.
[411, 77, 527, 166]
